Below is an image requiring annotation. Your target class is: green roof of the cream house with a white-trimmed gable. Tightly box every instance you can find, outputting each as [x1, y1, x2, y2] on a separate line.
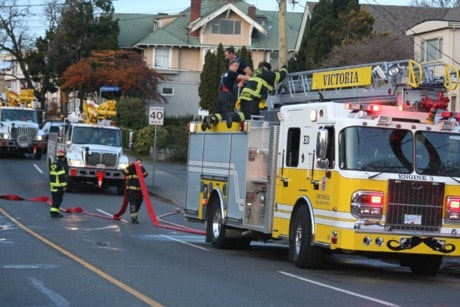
[114, 0, 303, 50]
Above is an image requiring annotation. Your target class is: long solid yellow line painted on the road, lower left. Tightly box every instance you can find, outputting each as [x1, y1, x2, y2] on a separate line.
[0, 208, 163, 307]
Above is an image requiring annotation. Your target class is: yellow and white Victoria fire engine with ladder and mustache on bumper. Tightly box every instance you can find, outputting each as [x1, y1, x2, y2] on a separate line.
[184, 60, 460, 275]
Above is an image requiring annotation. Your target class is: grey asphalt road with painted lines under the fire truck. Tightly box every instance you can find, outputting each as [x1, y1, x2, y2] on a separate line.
[0, 156, 460, 306]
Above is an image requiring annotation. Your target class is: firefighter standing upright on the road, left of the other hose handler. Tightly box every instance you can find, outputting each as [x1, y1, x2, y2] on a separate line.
[50, 150, 67, 218]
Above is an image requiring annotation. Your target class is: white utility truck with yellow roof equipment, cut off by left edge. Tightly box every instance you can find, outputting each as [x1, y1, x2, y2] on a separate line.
[0, 88, 46, 160]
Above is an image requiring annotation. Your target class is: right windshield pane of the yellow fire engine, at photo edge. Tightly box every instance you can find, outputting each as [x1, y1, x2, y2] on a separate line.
[415, 131, 460, 177]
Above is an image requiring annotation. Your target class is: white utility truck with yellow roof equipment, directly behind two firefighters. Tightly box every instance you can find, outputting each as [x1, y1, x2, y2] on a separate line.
[47, 101, 129, 195]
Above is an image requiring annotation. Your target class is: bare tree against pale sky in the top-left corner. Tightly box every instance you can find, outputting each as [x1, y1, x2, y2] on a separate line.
[0, 0, 34, 88]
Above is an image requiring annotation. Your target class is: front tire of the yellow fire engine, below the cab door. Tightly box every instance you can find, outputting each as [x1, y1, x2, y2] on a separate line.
[289, 206, 323, 269]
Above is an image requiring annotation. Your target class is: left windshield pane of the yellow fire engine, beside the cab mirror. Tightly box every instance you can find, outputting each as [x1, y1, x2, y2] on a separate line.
[339, 127, 413, 173]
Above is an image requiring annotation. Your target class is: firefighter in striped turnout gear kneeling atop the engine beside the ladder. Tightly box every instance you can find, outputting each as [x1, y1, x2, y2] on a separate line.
[227, 62, 288, 128]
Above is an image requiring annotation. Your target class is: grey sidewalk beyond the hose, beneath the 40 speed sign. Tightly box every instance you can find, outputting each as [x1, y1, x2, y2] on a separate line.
[129, 156, 187, 208]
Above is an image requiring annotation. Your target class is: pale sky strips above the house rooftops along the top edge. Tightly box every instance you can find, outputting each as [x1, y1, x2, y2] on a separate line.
[112, 0, 411, 14]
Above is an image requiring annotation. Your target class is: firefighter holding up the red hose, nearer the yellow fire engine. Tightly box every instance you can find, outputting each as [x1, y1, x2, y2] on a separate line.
[123, 159, 148, 224]
